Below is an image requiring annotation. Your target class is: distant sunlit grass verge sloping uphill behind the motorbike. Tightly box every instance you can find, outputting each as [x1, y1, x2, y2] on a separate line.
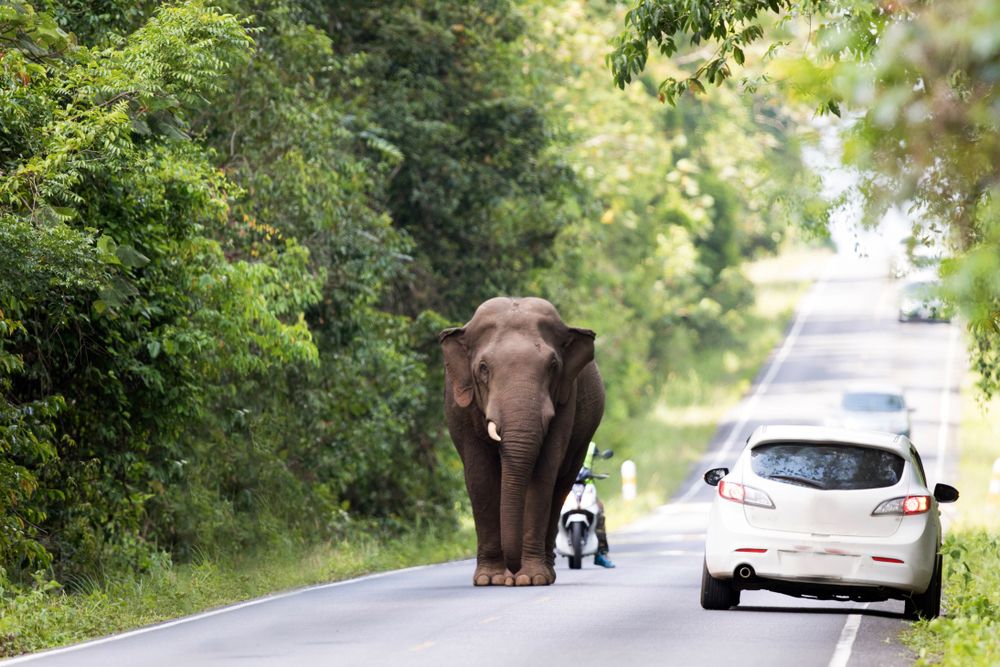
[595, 247, 830, 528]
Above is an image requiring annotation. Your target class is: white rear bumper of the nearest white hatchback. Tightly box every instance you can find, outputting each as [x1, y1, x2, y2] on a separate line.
[705, 500, 939, 597]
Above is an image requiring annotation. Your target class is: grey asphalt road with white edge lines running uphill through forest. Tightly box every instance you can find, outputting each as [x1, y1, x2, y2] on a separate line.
[5, 252, 964, 667]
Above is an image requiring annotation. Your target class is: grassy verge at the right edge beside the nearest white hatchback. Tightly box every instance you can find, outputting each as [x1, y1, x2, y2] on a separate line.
[903, 376, 1000, 667]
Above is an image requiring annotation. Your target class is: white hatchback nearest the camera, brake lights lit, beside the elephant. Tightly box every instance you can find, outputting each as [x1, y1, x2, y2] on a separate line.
[701, 426, 958, 618]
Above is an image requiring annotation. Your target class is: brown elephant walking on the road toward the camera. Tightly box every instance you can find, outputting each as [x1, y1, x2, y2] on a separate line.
[438, 297, 604, 586]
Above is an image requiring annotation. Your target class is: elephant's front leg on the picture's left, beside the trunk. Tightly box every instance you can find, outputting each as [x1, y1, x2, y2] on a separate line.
[463, 445, 509, 586]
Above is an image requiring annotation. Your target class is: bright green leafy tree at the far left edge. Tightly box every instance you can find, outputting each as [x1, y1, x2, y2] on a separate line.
[0, 1, 318, 569]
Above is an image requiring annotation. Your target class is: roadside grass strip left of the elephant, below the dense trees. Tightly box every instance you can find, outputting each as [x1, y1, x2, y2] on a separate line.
[0, 529, 475, 657]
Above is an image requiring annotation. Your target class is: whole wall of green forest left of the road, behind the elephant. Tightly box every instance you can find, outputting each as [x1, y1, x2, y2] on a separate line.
[0, 0, 823, 580]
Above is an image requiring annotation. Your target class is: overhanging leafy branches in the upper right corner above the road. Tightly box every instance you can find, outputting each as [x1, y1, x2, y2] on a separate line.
[608, 0, 1000, 398]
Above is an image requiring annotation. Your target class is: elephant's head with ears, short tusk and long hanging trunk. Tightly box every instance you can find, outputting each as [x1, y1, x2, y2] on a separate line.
[439, 297, 594, 572]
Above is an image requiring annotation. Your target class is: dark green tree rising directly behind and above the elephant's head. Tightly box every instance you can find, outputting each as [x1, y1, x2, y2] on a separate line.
[317, 0, 572, 322]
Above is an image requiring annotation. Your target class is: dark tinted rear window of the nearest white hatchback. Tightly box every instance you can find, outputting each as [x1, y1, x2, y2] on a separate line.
[750, 442, 906, 490]
